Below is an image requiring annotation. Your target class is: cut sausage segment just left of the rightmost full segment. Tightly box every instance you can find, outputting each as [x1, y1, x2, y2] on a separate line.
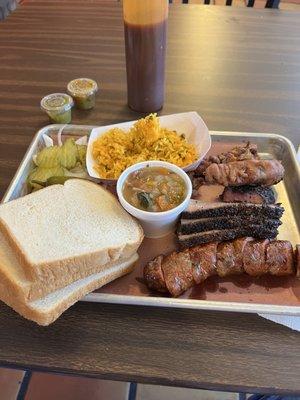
[243, 239, 269, 276]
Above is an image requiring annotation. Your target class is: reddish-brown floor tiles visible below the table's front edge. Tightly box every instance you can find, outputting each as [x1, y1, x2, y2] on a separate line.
[0, 369, 243, 400]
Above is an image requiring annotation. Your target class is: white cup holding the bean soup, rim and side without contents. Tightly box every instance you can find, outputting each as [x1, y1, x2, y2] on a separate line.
[117, 161, 192, 238]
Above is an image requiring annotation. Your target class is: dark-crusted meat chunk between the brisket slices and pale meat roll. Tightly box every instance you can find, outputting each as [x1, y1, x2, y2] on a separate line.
[220, 185, 275, 204]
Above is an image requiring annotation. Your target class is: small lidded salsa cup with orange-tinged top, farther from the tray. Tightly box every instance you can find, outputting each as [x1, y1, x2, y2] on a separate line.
[68, 78, 98, 110]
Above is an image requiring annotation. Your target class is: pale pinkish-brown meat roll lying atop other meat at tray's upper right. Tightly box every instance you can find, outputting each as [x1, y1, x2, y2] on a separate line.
[205, 160, 284, 186]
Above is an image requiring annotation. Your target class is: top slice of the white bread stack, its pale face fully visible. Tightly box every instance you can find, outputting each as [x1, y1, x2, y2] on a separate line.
[0, 179, 143, 282]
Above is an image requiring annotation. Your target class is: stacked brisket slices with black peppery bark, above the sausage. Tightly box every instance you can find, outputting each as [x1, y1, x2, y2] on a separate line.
[177, 200, 284, 248]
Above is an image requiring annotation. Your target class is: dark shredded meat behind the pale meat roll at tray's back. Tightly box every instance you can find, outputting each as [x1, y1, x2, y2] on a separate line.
[194, 142, 259, 178]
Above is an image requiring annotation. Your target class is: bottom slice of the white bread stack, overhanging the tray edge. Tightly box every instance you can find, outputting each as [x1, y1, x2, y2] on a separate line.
[0, 254, 138, 325]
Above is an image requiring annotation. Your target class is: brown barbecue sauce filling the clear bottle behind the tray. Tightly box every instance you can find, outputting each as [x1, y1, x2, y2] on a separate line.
[124, 19, 167, 113]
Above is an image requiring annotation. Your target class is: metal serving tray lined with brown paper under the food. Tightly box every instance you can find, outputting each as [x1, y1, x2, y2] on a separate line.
[2, 125, 300, 315]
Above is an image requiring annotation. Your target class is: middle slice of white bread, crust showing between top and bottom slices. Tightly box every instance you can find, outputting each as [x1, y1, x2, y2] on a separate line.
[0, 232, 132, 302]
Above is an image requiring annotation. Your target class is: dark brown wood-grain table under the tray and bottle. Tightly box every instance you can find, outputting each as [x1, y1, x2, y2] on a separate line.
[0, 0, 300, 394]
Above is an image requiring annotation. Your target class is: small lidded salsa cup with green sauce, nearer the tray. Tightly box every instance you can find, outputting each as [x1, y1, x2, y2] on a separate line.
[41, 93, 74, 124]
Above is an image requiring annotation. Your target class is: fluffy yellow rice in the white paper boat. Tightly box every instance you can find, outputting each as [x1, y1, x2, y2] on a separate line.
[92, 114, 197, 179]
